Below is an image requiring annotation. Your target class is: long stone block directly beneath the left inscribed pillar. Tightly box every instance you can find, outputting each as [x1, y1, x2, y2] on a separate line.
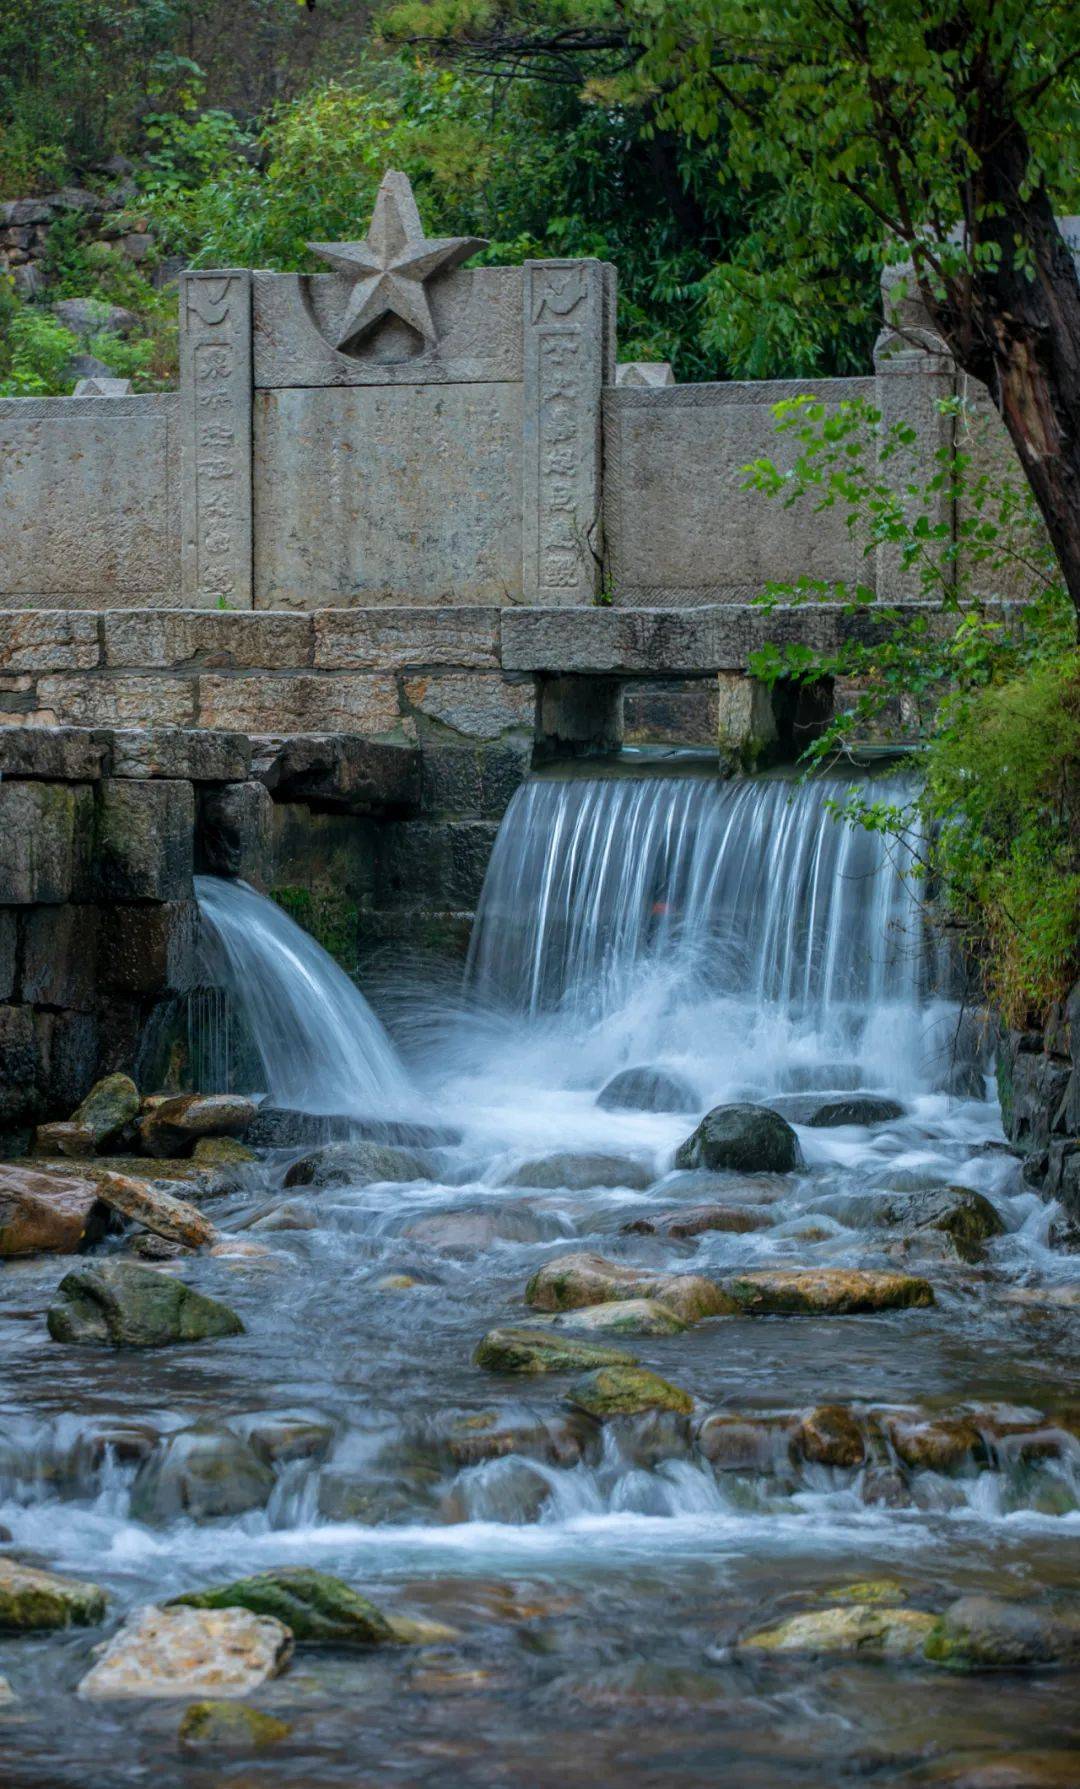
[102, 608, 311, 671]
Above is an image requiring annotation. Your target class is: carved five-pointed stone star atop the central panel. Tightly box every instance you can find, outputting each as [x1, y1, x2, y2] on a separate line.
[308, 170, 486, 349]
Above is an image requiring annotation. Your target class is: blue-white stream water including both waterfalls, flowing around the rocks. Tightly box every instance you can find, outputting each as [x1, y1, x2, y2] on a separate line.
[0, 778, 1080, 1789]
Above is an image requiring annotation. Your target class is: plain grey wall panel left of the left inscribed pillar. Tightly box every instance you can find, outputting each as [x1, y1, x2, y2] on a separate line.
[0, 393, 179, 608]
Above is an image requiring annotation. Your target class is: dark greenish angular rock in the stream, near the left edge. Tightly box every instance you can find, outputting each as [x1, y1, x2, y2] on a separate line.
[48, 1261, 243, 1347]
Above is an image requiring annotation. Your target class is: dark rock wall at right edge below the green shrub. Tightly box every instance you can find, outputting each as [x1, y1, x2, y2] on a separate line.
[998, 982, 1080, 1224]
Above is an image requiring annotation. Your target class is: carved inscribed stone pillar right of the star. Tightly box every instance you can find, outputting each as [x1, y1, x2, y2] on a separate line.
[522, 261, 606, 606]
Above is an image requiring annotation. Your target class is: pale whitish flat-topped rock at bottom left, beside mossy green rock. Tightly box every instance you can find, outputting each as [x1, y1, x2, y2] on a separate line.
[79, 1607, 293, 1700]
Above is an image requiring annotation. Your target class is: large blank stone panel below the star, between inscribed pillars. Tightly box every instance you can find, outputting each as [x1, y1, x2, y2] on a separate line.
[254, 383, 522, 608]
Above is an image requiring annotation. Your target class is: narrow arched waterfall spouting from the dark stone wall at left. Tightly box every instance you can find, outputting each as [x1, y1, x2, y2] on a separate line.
[195, 877, 411, 1116]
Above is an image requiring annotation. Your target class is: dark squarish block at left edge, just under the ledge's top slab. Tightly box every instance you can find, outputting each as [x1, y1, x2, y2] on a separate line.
[0, 782, 93, 907]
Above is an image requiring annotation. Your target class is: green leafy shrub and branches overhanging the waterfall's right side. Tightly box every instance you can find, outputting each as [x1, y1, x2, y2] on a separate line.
[746, 399, 1080, 1025]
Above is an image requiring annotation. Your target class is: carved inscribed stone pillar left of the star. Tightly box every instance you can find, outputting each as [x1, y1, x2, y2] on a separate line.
[181, 268, 252, 608]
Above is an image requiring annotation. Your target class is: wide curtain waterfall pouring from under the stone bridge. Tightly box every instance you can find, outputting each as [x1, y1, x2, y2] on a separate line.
[467, 776, 942, 1088]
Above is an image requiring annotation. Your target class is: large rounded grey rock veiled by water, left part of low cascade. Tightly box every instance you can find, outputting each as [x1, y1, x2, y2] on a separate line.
[131, 1424, 275, 1522]
